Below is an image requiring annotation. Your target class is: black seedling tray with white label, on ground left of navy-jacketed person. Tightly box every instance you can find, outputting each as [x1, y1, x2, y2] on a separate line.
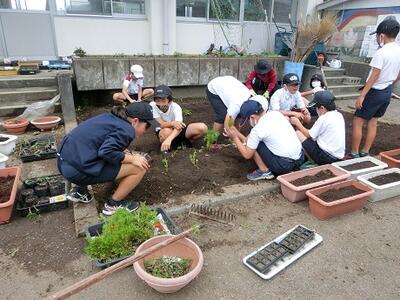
[16, 175, 69, 217]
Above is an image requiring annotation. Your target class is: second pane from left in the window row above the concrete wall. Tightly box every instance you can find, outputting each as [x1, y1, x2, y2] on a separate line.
[209, 0, 240, 21]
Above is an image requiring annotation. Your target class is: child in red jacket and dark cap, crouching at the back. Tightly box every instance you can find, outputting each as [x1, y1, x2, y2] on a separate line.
[245, 59, 277, 99]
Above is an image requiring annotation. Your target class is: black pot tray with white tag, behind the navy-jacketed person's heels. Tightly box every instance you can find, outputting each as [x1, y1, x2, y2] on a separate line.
[16, 175, 69, 217]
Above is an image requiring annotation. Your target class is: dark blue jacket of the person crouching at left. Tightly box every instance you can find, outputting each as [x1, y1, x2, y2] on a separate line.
[59, 113, 135, 176]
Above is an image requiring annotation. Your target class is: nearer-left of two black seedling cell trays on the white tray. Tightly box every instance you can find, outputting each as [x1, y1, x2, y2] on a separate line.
[247, 242, 288, 273]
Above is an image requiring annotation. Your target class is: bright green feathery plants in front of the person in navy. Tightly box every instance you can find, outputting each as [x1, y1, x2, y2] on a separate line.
[85, 203, 157, 261]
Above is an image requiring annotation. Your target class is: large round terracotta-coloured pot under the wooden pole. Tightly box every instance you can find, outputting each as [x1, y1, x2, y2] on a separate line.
[133, 235, 204, 293]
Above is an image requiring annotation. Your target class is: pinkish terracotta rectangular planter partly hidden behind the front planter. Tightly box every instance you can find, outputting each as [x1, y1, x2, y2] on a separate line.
[277, 165, 350, 202]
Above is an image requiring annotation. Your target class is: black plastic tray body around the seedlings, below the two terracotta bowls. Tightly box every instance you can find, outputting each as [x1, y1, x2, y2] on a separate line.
[19, 135, 57, 162]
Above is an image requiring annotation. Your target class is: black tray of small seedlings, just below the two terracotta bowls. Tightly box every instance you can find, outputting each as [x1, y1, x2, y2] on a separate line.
[17, 135, 57, 162]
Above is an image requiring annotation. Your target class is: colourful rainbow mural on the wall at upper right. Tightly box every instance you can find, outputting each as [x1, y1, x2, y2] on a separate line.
[327, 6, 400, 57]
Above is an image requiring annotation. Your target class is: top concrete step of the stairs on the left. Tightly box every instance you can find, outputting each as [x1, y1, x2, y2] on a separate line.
[0, 76, 57, 89]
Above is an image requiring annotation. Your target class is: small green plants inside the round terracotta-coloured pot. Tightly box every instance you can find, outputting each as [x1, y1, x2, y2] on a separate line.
[144, 255, 192, 278]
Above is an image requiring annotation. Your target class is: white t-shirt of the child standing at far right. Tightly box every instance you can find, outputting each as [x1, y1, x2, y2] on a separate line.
[367, 42, 400, 90]
